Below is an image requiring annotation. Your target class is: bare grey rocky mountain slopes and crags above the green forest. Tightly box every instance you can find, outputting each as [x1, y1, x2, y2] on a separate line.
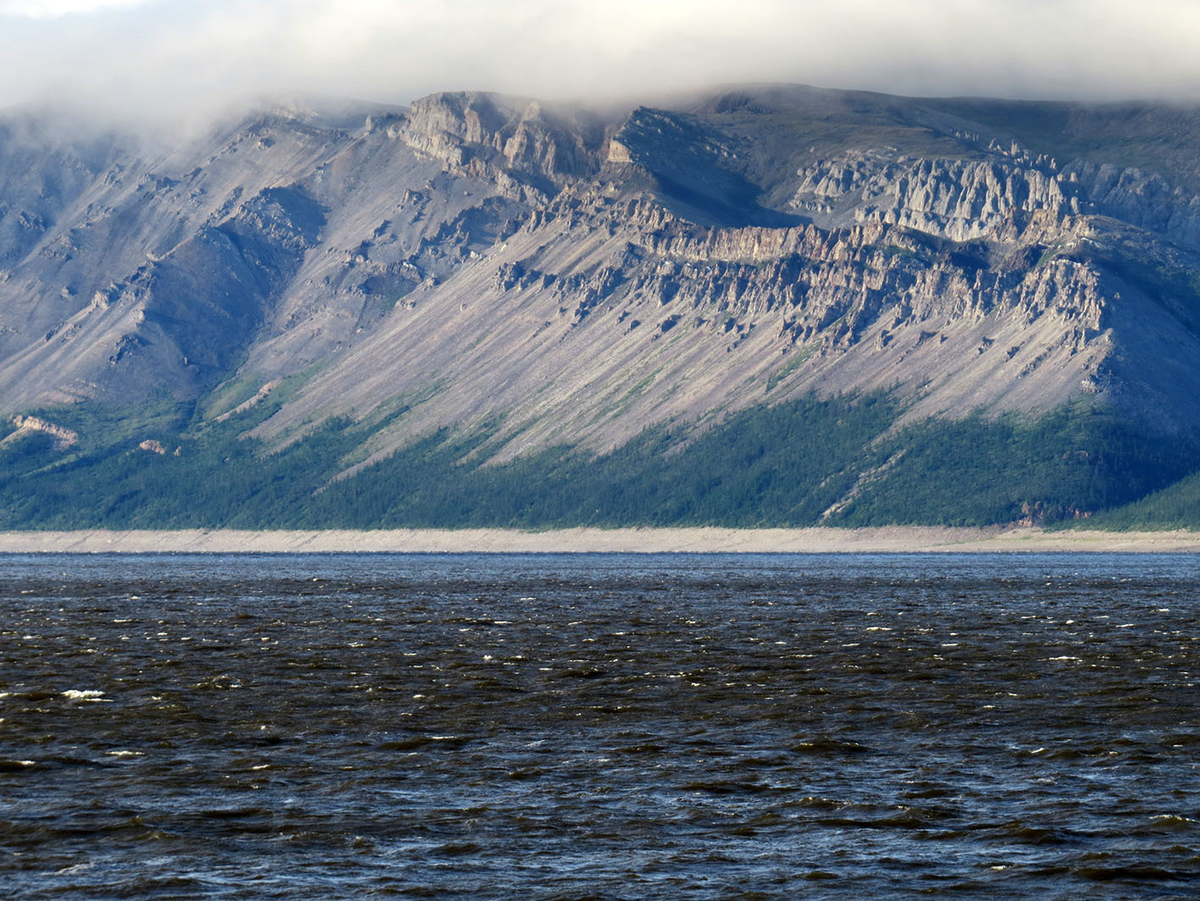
[0, 89, 1200, 467]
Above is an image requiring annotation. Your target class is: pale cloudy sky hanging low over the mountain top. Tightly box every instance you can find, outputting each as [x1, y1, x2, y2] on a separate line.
[0, 0, 1200, 122]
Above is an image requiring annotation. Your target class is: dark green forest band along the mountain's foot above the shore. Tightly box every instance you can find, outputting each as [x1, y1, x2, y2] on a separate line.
[0, 395, 1200, 529]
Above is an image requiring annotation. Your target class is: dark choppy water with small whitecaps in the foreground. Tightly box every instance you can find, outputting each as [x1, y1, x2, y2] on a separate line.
[0, 555, 1200, 899]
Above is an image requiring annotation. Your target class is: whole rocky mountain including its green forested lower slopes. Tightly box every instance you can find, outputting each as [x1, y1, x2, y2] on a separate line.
[0, 85, 1200, 527]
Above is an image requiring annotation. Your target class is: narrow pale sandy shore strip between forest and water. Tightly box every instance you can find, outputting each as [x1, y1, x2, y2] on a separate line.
[0, 527, 1200, 553]
